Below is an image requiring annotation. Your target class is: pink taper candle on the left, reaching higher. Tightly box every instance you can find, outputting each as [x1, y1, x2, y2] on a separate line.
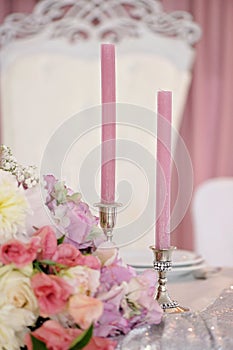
[101, 44, 116, 203]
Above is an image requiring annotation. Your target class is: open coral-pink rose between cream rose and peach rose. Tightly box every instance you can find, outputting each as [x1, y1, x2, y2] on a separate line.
[31, 273, 73, 316]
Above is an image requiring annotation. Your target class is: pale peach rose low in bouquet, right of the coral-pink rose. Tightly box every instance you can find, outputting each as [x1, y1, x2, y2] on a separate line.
[68, 294, 103, 329]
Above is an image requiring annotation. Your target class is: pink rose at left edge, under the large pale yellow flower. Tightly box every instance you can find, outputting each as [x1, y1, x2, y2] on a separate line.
[0, 237, 40, 267]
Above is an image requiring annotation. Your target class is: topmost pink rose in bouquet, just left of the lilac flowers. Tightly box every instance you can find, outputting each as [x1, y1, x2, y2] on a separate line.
[35, 226, 57, 260]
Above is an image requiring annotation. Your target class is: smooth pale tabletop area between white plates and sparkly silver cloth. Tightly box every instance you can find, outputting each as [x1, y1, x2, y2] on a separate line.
[168, 267, 233, 312]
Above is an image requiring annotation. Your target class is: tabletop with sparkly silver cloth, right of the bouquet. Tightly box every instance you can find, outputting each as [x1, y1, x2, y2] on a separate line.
[118, 267, 233, 350]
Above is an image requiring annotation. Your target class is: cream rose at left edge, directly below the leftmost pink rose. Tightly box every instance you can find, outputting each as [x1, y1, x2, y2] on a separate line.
[0, 265, 38, 313]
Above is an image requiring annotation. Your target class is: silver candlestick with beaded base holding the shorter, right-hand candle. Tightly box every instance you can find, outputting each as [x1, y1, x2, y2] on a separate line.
[150, 246, 189, 313]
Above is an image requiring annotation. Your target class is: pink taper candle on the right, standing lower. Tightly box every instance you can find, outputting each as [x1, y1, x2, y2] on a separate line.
[155, 91, 172, 249]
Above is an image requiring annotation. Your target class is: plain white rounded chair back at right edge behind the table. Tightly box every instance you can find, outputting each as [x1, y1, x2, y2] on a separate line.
[192, 177, 233, 266]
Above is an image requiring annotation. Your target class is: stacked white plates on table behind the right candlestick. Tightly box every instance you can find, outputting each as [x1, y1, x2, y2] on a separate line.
[120, 249, 203, 268]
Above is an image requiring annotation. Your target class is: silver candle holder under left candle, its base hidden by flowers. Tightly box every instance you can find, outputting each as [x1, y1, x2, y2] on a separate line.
[94, 202, 122, 248]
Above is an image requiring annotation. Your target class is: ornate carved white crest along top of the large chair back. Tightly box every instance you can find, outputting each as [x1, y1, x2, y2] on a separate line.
[0, 0, 201, 47]
